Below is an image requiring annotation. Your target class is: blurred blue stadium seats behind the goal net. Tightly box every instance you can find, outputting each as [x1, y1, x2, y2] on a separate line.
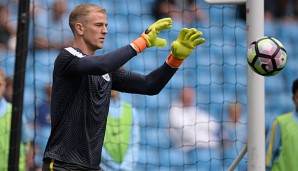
[0, 0, 298, 170]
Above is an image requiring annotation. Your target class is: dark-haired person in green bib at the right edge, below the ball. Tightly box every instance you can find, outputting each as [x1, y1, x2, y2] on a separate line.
[266, 79, 298, 171]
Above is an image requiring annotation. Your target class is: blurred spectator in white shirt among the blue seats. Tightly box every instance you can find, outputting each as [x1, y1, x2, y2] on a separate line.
[169, 87, 221, 171]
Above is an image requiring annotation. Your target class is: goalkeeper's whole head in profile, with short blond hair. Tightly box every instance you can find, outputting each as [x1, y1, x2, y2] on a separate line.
[69, 4, 108, 54]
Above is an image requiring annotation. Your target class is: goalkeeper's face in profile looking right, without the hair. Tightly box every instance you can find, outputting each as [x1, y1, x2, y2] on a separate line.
[83, 12, 108, 51]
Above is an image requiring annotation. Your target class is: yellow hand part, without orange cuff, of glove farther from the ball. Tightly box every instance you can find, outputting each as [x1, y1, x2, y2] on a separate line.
[142, 18, 172, 47]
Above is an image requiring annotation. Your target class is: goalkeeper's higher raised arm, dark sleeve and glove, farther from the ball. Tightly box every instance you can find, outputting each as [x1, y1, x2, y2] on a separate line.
[77, 18, 172, 75]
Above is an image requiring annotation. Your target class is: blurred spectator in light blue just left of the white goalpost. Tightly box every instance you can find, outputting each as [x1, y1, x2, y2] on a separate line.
[222, 102, 247, 170]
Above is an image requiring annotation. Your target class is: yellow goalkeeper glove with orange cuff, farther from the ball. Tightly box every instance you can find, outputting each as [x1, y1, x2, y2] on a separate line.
[132, 18, 172, 53]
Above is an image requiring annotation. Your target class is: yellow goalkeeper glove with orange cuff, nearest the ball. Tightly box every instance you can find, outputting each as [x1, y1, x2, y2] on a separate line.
[167, 28, 206, 68]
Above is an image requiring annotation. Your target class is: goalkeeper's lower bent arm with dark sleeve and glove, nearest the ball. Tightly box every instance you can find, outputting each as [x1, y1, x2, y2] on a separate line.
[112, 28, 205, 95]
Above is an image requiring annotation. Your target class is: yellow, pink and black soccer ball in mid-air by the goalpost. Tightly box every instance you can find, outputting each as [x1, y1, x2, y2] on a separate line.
[247, 36, 287, 76]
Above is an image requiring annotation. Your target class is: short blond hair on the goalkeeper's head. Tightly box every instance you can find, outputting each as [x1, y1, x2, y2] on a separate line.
[69, 4, 106, 34]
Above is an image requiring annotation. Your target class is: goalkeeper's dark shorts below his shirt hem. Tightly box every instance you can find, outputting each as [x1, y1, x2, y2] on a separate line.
[42, 158, 101, 171]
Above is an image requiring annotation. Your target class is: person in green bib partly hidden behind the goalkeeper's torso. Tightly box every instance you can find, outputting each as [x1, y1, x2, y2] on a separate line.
[100, 90, 140, 171]
